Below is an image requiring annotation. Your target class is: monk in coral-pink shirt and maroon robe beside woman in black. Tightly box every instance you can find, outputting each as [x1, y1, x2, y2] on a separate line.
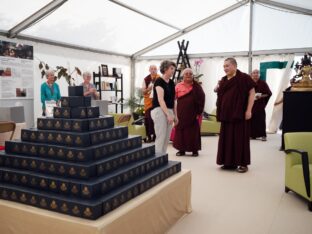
[173, 68, 205, 157]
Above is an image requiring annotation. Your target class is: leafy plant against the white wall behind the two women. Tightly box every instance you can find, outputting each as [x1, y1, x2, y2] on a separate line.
[39, 61, 81, 86]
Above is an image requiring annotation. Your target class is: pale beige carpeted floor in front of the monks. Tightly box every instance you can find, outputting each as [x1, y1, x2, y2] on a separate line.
[168, 134, 312, 234]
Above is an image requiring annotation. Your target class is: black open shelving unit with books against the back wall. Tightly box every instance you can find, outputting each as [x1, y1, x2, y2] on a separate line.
[93, 69, 124, 113]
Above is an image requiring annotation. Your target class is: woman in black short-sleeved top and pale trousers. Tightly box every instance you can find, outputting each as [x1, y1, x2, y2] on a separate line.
[151, 60, 178, 153]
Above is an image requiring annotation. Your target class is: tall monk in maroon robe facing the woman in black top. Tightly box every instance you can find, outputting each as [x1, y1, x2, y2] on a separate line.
[217, 58, 255, 172]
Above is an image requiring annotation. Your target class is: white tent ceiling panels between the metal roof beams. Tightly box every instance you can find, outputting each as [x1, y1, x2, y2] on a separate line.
[0, 0, 312, 55]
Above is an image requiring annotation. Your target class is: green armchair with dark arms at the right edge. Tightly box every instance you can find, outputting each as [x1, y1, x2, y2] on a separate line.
[284, 132, 312, 211]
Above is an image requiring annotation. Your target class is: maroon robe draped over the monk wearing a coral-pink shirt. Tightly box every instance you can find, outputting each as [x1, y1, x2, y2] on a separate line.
[173, 82, 205, 152]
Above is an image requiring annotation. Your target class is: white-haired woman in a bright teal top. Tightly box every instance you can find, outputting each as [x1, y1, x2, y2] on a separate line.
[41, 70, 61, 116]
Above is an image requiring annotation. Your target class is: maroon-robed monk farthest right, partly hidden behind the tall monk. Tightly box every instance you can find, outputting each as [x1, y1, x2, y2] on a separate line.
[250, 69, 272, 141]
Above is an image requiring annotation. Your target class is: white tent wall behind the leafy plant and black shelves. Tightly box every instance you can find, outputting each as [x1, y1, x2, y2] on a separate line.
[0, 36, 131, 125]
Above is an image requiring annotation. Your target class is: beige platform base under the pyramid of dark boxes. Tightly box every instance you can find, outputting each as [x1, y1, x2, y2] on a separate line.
[0, 170, 192, 234]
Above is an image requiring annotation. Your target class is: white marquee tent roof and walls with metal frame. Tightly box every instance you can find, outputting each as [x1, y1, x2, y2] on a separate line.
[0, 0, 312, 126]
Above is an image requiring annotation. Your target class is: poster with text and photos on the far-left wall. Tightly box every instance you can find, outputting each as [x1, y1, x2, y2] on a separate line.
[0, 40, 34, 99]
